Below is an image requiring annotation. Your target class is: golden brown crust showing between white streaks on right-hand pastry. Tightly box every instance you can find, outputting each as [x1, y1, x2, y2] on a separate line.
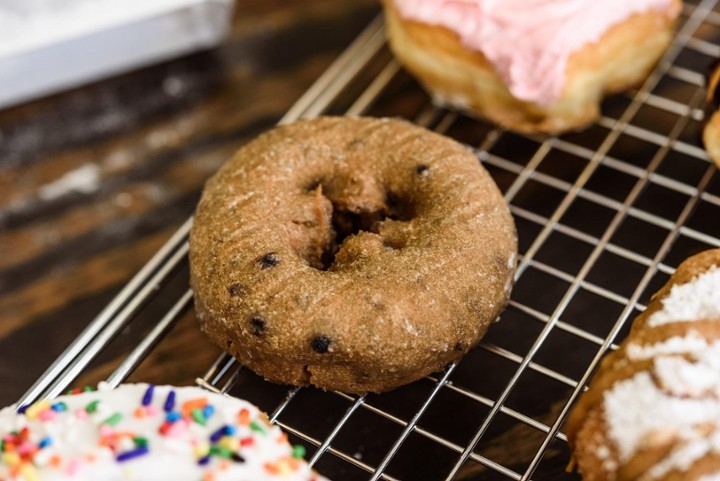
[566, 249, 720, 481]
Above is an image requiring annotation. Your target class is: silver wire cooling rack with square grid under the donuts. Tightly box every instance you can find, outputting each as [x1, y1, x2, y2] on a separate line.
[15, 0, 720, 480]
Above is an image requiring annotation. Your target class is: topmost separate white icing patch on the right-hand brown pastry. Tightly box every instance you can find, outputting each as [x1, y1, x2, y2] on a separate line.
[648, 266, 720, 327]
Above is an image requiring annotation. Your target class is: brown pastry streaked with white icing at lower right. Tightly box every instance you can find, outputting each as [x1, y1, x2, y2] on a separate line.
[567, 249, 720, 481]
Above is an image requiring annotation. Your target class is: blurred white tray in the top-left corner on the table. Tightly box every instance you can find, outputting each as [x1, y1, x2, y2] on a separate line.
[0, 0, 234, 108]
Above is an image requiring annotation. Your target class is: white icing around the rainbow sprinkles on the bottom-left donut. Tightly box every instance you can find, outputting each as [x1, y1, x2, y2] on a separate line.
[0, 384, 325, 481]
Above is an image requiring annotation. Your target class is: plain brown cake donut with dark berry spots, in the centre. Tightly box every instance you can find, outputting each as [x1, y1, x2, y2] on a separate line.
[190, 117, 517, 392]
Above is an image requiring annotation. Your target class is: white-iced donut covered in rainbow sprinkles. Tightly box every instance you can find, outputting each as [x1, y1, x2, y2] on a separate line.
[0, 384, 325, 481]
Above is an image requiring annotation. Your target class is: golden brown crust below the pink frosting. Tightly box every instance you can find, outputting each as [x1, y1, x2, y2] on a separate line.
[383, 0, 680, 133]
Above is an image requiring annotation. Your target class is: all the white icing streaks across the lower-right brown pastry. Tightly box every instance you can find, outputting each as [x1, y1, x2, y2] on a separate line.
[603, 267, 720, 481]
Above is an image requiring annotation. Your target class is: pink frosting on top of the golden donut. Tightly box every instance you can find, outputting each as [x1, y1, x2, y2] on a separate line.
[394, 0, 678, 105]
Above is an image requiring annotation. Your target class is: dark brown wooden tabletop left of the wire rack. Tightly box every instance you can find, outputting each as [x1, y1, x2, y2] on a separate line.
[0, 0, 379, 405]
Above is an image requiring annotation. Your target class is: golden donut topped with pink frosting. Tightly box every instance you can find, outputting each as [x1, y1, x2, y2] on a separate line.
[383, 0, 681, 133]
